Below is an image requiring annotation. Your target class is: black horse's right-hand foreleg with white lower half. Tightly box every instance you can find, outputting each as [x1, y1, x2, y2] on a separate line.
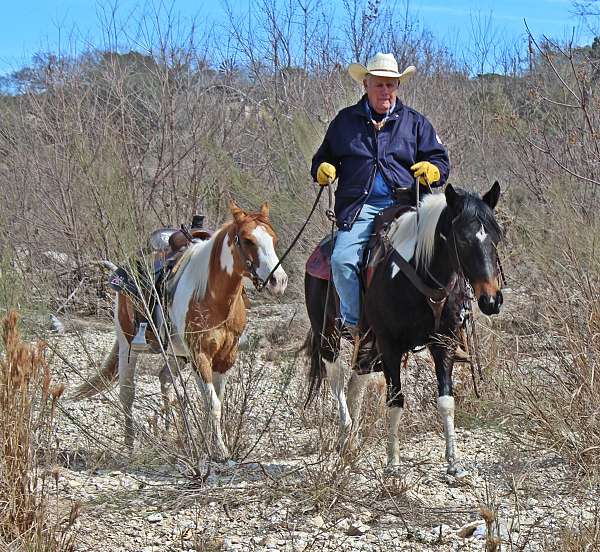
[429, 344, 465, 475]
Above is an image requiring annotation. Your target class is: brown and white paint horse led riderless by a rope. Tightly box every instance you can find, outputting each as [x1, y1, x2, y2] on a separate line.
[74, 201, 287, 459]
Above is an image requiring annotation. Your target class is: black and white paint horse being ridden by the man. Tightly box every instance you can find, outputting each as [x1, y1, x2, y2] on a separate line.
[305, 182, 502, 474]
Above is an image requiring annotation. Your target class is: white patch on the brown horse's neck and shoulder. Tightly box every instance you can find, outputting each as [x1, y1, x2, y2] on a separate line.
[170, 234, 218, 336]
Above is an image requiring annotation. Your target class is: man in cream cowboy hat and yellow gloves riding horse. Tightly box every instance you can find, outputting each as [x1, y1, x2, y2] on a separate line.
[311, 53, 450, 371]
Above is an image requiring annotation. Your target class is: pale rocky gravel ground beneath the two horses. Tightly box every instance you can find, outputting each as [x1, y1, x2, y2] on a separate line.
[39, 298, 597, 552]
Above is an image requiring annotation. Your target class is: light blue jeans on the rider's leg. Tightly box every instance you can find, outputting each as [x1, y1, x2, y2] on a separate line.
[331, 199, 393, 326]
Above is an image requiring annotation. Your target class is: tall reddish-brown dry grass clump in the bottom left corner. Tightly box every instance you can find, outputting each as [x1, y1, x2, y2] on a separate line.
[0, 311, 79, 552]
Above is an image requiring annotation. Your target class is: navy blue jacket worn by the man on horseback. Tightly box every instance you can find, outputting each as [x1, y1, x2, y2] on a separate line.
[311, 95, 450, 230]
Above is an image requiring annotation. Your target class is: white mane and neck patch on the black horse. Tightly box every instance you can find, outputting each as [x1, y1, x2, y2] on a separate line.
[388, 194, 446, 266]
